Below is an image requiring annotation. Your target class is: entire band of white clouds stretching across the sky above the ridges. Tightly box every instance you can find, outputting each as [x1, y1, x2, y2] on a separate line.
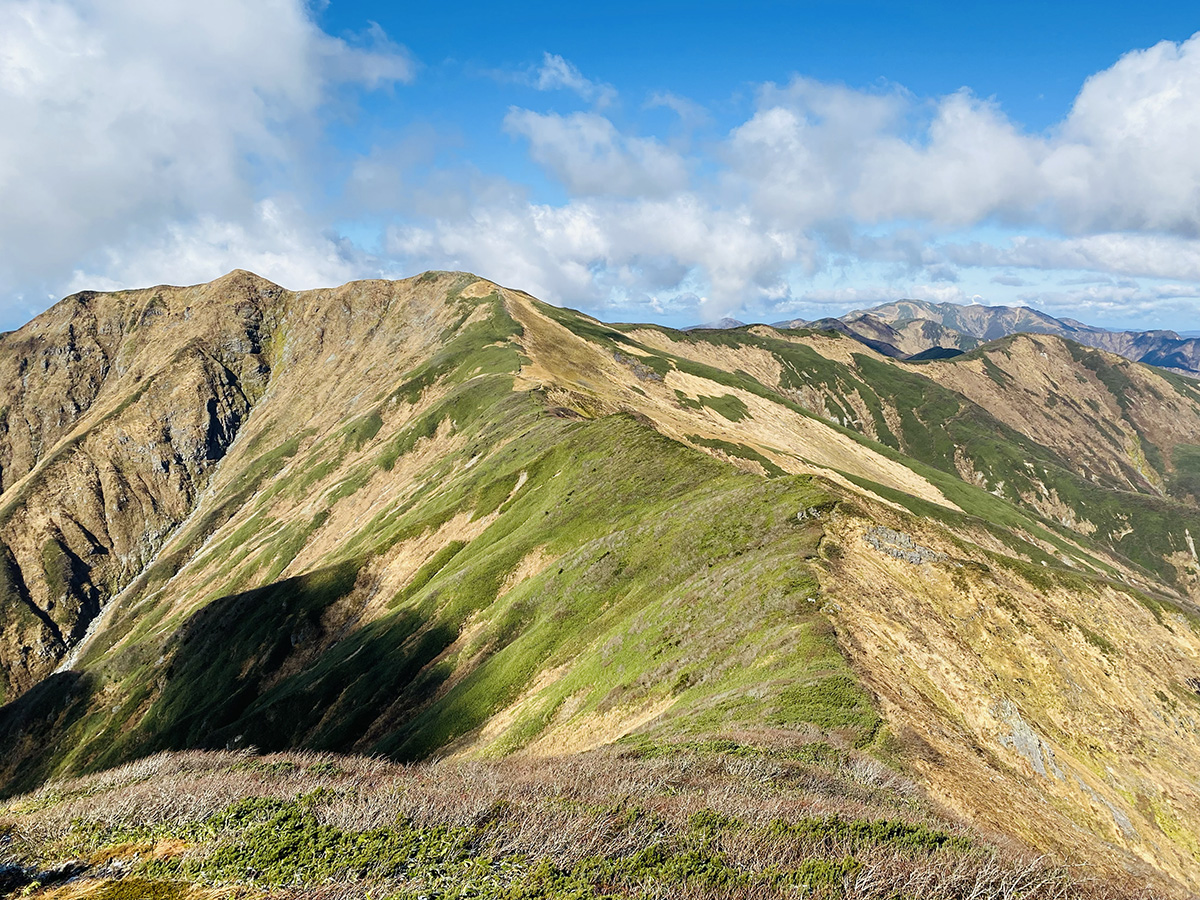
[0, 20, 1200, 331]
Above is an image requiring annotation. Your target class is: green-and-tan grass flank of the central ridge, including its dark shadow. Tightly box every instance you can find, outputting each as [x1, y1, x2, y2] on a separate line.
[6, 277, 880, 786]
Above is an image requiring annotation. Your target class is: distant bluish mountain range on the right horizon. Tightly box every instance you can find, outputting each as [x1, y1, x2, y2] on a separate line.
[753, 300, 1200, 377]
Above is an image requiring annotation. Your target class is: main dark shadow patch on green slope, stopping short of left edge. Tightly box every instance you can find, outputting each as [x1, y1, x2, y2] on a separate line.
[86, 560, 457, 768]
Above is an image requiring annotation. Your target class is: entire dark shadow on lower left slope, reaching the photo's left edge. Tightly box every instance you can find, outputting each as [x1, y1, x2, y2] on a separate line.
[0, 560, 468, 794]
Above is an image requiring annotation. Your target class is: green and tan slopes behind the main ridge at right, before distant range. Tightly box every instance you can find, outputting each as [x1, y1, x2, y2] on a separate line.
[609, 326, 1200, 600]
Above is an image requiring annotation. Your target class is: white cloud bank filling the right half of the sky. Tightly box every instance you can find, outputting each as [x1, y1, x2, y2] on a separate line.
[446, 35, 1200, 324]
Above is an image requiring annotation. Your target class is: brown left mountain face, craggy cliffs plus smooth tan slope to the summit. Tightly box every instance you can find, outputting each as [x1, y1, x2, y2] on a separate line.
[0, 271, 492, 697]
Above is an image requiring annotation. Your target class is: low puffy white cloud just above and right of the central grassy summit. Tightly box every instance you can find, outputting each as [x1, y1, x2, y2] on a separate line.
[388, 192, 816, 316]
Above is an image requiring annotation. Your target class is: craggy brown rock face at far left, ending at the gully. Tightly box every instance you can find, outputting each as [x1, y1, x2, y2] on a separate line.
[0, 272, 283, 694]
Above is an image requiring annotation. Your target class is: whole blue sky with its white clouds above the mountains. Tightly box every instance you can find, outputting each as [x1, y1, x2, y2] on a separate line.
[0, 0, 1200, 330]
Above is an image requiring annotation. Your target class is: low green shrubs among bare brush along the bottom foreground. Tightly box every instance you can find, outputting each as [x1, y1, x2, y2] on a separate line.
[51, 790, 983, 900]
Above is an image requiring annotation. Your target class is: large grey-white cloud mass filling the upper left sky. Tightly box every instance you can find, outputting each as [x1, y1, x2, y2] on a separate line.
[0, 0, 413, 321]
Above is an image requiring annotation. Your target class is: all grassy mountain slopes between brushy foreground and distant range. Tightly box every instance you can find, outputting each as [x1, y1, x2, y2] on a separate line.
[0, 272, 1200, 889]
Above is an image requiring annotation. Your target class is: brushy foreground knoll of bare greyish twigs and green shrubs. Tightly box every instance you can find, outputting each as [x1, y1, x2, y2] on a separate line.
[0, 742, 1151, 900]
